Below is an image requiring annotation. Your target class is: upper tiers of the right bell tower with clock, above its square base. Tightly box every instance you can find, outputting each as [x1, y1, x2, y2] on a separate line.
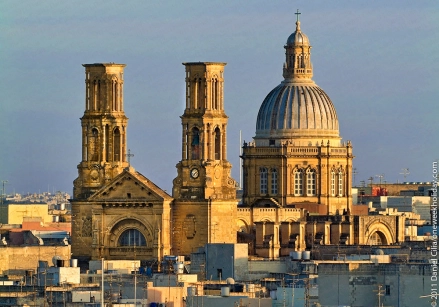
[173, 62, 236, 200]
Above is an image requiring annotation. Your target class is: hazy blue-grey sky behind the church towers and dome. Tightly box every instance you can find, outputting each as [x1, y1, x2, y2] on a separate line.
[0, 0, 439, 194]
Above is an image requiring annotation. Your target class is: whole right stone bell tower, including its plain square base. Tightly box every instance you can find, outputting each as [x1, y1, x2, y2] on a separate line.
[172, 62, 237, 253]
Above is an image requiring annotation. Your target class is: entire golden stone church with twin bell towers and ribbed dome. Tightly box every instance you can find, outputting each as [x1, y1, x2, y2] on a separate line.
[71, 15, 405, 261]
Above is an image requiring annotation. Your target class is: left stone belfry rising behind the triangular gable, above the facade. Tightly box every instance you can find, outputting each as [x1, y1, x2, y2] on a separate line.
[73, 63, 129, 199]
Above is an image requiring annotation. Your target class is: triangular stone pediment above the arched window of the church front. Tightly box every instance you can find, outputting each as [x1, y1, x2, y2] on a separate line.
[88, 169, 172, 202]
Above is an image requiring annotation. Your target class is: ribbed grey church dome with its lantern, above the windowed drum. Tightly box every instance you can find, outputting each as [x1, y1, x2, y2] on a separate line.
[254, 15, 340, 143]
